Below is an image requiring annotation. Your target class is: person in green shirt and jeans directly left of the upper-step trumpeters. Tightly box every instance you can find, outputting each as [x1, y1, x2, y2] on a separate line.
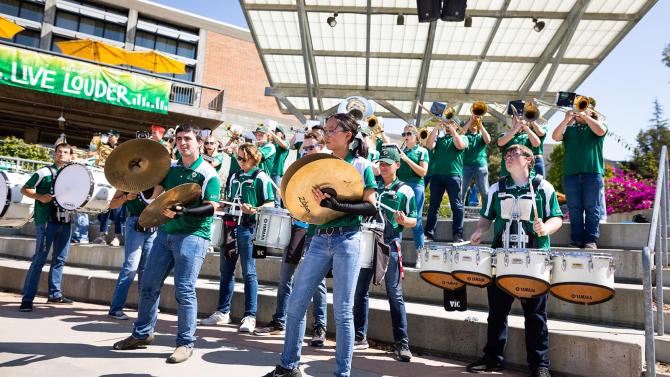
[397, 124, 430, 250]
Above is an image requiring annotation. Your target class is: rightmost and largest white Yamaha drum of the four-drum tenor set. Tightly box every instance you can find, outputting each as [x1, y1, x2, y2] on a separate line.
[551, 252, 616, 305]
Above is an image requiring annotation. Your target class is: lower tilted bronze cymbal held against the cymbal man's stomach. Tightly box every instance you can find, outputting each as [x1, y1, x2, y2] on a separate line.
[139, 183, 202, 228]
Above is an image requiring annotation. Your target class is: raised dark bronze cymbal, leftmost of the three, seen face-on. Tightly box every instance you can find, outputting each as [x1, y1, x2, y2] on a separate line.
[105, 139, 170, 192]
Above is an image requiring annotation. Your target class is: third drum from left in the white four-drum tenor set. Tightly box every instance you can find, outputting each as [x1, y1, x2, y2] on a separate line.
[495, 249, 551, 298]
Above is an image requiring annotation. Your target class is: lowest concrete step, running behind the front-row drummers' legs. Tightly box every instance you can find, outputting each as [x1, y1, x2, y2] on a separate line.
[0, 258, 644, 377]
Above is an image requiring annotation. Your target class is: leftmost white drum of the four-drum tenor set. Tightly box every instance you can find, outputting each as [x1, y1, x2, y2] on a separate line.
[417, 244, 465, 291]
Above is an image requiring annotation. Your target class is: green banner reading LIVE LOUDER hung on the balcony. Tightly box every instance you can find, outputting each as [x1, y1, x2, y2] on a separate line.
[0, 45, 171, 114]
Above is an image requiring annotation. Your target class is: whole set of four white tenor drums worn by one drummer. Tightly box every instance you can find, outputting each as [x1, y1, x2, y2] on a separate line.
[417, 244, 615, 305]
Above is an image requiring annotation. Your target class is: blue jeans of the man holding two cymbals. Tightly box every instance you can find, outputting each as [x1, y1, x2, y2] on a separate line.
[133, 229, 209, 347]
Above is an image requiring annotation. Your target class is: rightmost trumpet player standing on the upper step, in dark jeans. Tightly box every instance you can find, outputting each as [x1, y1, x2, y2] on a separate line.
[552, 104, 607, 249]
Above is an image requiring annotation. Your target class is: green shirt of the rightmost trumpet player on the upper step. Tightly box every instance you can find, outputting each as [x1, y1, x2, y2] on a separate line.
[563, 123, 607, 176]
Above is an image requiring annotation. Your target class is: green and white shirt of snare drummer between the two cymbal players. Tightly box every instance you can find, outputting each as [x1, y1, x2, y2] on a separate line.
[226, 167, 275, 220]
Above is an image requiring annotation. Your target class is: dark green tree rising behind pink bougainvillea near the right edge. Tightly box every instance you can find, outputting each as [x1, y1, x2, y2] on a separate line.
[631, 99, 670, 178]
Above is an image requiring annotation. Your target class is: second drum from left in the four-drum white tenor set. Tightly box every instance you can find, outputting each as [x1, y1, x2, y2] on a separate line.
[451, 246, 494, 287]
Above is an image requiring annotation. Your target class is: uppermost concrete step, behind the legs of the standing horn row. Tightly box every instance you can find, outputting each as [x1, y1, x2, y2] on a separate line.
[403, 219, 649, 250]
